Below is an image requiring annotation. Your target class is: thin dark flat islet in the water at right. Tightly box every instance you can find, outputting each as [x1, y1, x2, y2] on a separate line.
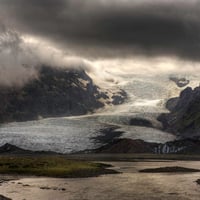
[139, 166, 200, 173]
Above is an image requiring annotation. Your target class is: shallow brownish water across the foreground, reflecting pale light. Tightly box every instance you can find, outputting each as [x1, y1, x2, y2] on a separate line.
[0, 161, 200, 200]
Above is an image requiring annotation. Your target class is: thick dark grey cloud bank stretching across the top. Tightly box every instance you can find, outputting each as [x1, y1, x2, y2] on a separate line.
[0, 0, 200, 60]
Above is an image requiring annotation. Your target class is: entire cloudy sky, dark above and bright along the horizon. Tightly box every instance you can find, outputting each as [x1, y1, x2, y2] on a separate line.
[0, 0, 200, 84]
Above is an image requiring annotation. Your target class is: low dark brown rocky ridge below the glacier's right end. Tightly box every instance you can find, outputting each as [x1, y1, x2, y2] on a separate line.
[95, 139, 200, 154]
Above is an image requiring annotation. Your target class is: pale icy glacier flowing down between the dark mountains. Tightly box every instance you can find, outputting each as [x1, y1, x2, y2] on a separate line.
[0, 74, 197, 153]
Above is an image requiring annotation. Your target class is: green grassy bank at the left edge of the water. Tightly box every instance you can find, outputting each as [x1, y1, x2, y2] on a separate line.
[0, 156, 117, 178]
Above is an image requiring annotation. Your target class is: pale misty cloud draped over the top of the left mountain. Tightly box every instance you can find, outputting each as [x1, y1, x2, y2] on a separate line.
[0, 24, 89, 86]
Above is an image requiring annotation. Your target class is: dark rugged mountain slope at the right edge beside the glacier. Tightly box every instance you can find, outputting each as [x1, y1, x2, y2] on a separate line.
[158, 87, 200, 137]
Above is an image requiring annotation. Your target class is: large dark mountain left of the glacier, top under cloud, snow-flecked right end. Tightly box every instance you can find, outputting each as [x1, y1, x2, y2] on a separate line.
[0, 66, 126, 122]
